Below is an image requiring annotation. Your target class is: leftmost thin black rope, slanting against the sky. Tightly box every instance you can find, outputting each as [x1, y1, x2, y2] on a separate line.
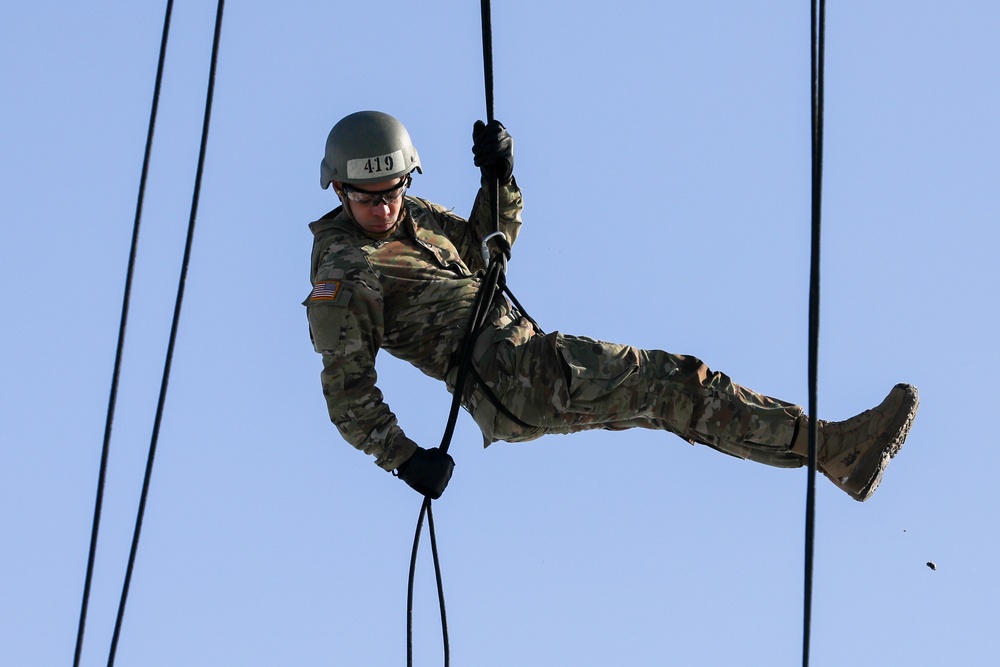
[73, 0, 174, 667]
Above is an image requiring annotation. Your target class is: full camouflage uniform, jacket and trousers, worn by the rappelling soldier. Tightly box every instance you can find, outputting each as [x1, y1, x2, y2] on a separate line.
[305, 182, 803, 470]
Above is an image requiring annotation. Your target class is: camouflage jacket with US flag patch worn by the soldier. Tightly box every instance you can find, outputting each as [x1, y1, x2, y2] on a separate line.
[304, 177, 522, 470]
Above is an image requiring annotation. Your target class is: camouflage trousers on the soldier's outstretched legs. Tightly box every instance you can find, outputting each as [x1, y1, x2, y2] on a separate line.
[465, 321, 803, 467]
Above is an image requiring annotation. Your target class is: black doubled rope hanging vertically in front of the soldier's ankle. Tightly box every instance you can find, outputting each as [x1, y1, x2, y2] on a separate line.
[802, 0, 826, 667]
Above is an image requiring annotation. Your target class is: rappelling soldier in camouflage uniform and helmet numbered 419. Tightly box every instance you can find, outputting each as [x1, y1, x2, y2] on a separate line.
[304, 111, 918, 501]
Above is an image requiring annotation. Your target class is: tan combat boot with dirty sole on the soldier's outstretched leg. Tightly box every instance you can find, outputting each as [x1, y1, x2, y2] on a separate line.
[792, 384, 920, 502]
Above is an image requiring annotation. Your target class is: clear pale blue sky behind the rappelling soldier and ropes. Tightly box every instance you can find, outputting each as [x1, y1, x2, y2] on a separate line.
[0, 0, 1000, 667]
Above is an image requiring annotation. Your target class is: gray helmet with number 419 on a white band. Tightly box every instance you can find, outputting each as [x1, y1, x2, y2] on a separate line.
[319, 111, 423, 190]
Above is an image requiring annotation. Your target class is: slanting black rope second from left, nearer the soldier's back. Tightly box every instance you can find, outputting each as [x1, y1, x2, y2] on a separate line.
[108, 0, 225, 667]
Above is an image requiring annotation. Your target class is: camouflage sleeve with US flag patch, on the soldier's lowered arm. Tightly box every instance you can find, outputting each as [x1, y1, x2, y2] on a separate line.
[305, 254, 415, 470]
